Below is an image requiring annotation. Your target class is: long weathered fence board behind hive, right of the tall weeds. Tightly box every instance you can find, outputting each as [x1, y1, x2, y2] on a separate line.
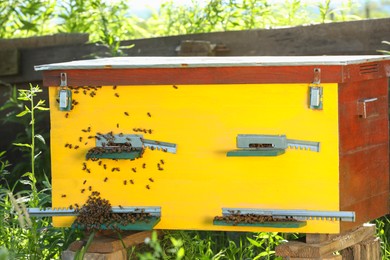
[122, 18, 390, 56]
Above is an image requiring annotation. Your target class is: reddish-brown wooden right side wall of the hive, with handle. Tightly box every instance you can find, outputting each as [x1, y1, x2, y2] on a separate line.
[339, 75, 389, 231]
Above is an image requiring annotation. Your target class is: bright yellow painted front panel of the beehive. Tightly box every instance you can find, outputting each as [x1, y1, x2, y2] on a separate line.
[50, 84, 339, 233]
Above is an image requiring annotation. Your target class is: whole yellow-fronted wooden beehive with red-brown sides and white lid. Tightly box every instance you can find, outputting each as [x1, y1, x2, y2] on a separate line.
[36, 56, 390, 233]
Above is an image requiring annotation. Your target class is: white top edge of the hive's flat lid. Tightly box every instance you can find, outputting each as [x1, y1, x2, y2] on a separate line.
[34, 55, 390, 71]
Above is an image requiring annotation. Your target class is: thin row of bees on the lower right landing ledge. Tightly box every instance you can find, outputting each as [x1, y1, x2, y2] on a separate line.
[214, 211, 297, 226]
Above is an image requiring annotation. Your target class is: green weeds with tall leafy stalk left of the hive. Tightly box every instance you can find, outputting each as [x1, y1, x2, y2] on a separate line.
[0, 84, 80, 259]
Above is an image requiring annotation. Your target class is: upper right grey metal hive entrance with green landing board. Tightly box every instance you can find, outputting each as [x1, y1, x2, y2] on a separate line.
[227, 134, 320, 156]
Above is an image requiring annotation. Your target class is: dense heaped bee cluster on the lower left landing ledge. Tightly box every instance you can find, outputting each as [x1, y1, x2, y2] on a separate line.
[74, 191, 151, 230]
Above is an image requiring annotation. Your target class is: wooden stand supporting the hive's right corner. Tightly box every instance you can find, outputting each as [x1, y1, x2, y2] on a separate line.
[276, 224, 381, 260]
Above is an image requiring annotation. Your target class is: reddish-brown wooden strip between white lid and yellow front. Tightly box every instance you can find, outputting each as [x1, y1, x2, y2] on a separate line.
[39, 66, 342, 86]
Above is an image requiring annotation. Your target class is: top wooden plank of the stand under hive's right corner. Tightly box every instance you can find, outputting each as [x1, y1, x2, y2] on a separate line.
[276, 224, 375, 258]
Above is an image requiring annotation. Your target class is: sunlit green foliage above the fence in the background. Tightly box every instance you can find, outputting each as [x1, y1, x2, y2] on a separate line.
[0, 0, 390, 42]
